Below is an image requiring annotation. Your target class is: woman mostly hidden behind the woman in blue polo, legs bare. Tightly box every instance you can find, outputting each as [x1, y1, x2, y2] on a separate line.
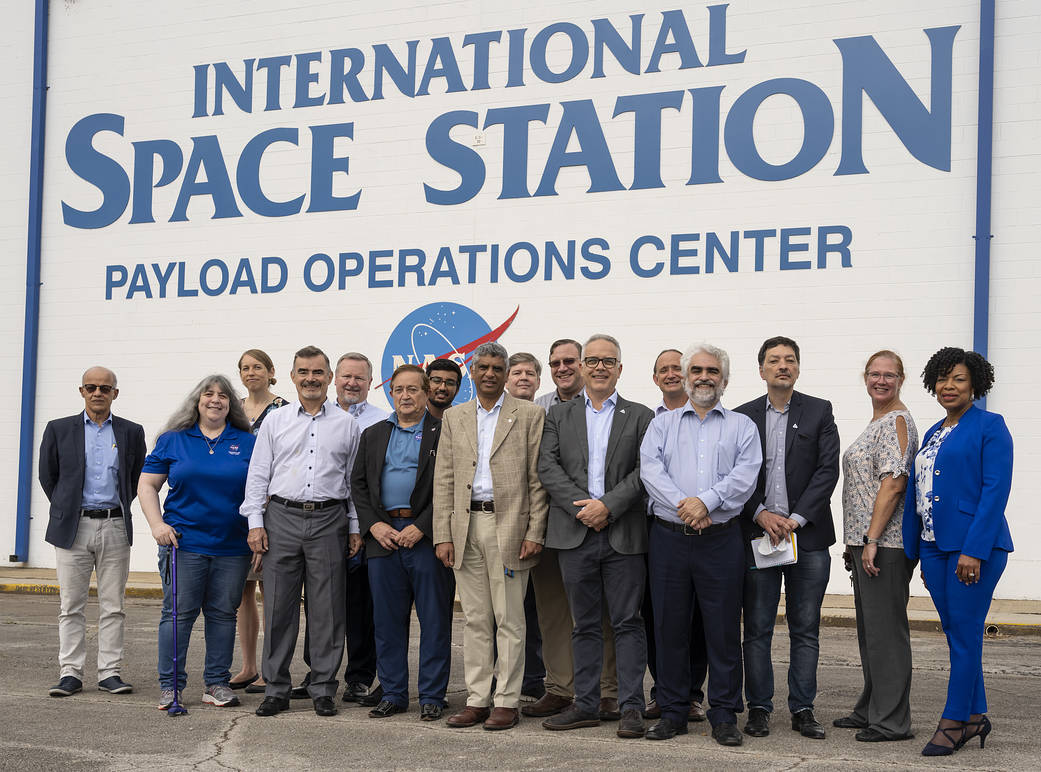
[230, 349, 288, 694]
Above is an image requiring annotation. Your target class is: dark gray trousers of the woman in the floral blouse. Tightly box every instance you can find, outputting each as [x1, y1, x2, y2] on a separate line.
[849, 546, 915, 738]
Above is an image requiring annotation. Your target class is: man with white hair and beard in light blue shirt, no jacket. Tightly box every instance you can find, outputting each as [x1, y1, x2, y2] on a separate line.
[640, 343, 763, 745]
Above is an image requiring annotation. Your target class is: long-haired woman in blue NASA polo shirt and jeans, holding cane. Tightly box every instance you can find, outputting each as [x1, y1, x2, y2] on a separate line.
[137, 376, 254, 710]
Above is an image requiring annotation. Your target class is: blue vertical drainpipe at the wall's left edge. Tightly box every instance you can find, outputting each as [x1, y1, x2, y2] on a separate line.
[10, 0, 48, 563]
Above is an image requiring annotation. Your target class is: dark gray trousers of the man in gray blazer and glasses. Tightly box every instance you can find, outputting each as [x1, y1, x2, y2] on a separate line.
[557, 529, 648, 715]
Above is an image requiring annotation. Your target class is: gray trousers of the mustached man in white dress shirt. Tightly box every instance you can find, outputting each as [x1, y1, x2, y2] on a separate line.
[262, 501, 347, 698]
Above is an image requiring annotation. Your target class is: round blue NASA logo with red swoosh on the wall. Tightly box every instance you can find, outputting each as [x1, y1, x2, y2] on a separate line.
[380, 303, 521, 405]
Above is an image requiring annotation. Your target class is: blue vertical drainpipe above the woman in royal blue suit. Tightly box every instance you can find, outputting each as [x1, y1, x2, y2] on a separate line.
[972, 0, 994, 408]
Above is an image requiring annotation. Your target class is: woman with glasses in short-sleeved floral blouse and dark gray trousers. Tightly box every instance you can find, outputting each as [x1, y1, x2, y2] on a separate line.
[834, 351, 918, 743]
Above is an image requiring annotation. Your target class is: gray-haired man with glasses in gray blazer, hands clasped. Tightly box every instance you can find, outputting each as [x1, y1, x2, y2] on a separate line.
[538, 335, 654, 738]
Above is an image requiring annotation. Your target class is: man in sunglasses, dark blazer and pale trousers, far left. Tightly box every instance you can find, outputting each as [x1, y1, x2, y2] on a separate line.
[40, 367, 146, 697]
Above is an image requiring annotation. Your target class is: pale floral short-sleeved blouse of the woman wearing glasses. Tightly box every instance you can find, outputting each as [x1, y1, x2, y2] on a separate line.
[842, 410, 918, 548]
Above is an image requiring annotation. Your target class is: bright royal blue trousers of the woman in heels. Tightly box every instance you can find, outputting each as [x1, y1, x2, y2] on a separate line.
[918, 541, 1009, 721]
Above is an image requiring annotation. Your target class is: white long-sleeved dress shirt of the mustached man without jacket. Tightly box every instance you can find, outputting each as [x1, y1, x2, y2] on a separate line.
[238, 400, 361, 534]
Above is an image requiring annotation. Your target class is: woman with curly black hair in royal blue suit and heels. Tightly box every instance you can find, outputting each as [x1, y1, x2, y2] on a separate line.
[904, 348, 1012, 755]
